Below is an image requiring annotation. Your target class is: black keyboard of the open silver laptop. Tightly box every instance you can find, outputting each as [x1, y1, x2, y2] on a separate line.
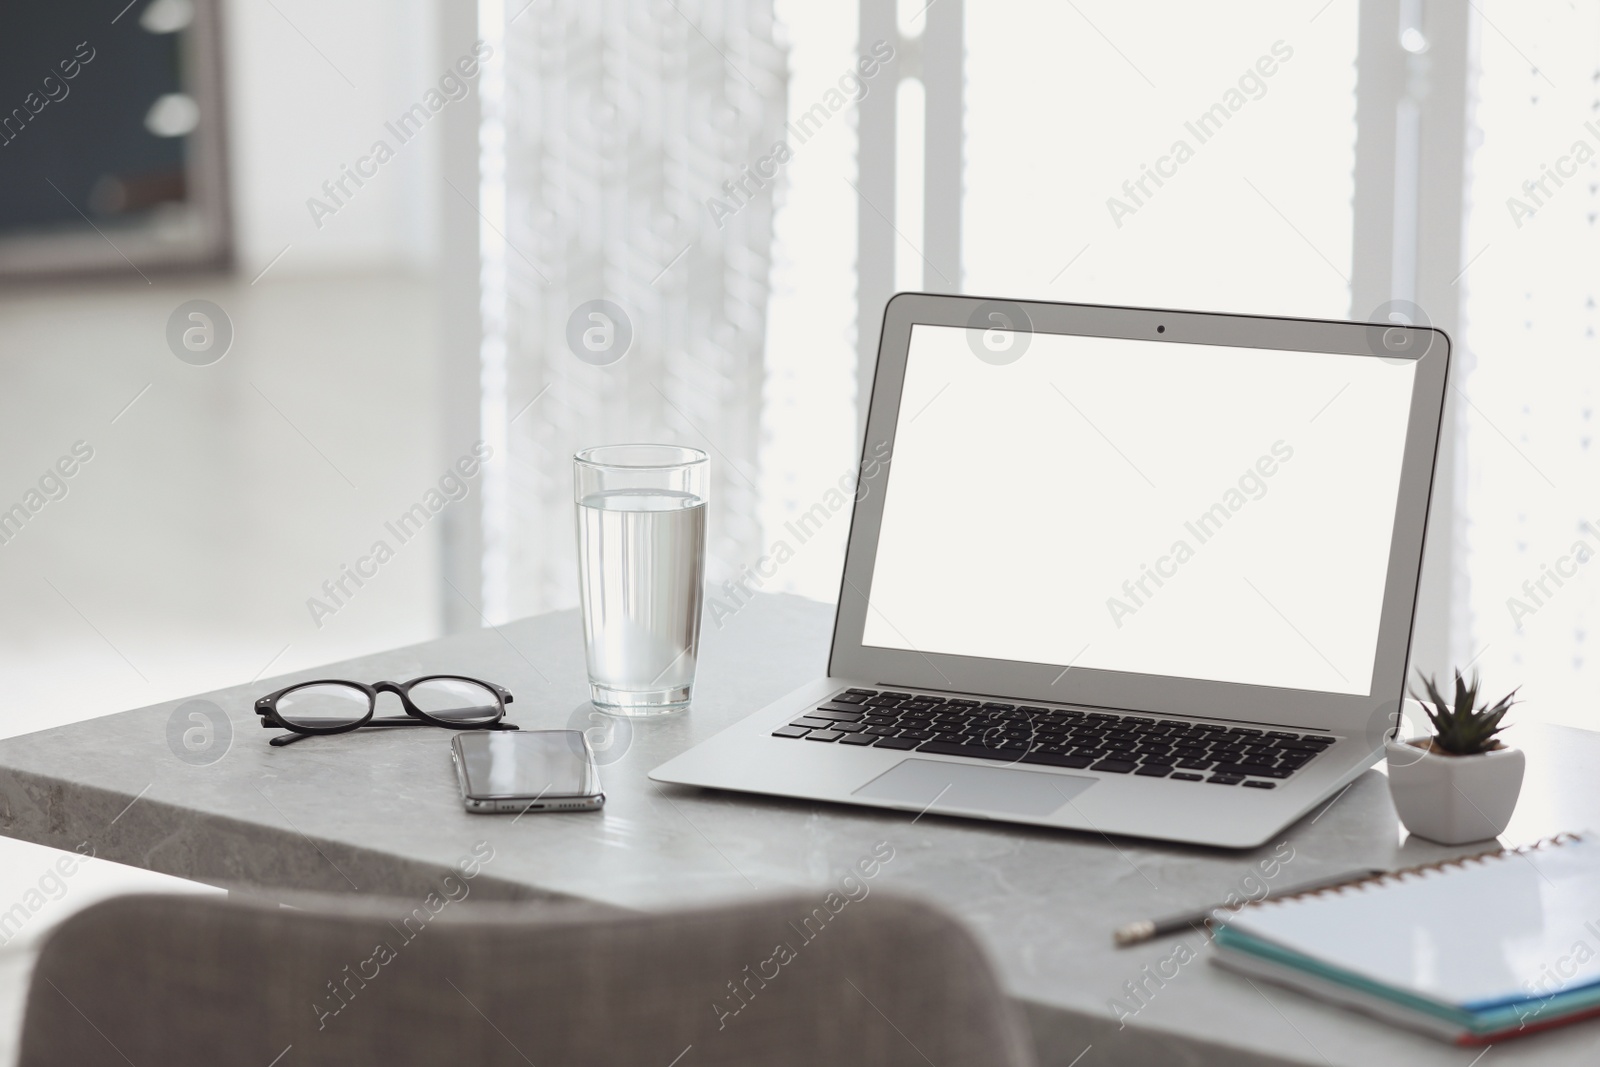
[773, 689, 1334, 789]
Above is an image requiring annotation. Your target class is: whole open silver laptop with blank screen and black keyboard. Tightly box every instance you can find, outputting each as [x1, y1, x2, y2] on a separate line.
[650, 293, 1450, 848]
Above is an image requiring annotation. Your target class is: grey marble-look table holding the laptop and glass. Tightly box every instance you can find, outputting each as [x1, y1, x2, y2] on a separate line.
[0, 597, 1600, 1067]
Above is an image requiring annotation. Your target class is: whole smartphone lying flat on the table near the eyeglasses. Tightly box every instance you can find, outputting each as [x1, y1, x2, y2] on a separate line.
[450, 729, 605, 813]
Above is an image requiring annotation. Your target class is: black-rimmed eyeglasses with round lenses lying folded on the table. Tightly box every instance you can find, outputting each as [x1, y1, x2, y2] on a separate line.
[256, 675, 517, 747]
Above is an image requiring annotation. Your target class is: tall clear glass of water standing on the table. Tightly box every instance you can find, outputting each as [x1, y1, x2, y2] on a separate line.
[573, 445, 710, 715]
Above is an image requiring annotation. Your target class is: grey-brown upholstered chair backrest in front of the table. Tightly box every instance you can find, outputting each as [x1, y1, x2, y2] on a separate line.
[19, 891, 1032, 1067]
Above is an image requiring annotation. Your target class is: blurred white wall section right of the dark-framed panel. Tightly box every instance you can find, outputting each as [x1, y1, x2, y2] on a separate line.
[222, 0, 438, 280]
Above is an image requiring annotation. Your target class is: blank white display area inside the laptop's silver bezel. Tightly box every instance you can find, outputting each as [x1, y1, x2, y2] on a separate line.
[862, 325, 1416, 694]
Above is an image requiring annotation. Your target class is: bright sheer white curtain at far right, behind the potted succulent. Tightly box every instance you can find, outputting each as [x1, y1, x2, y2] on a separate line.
[1458, 0, 1600, 728]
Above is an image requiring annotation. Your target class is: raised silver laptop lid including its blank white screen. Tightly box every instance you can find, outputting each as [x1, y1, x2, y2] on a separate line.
[830, 294, 1450, 729]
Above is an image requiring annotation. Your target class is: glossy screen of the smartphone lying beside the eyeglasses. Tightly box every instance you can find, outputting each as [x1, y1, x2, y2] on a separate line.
[456, 729, 600, 798]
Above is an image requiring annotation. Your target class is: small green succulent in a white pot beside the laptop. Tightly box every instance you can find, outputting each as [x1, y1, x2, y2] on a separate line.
[1386, 670, 1525, 845]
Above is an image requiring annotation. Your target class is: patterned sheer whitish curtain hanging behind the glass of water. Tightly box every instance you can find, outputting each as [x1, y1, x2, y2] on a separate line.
[482, 0, 787, 621]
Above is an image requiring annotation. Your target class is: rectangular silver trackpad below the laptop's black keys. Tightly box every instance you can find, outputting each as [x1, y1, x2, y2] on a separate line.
[853, 760, 1099, 816]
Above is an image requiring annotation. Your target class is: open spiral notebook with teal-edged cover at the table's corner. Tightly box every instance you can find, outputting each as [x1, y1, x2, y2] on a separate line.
[1213, 833, 1600, 1045]
